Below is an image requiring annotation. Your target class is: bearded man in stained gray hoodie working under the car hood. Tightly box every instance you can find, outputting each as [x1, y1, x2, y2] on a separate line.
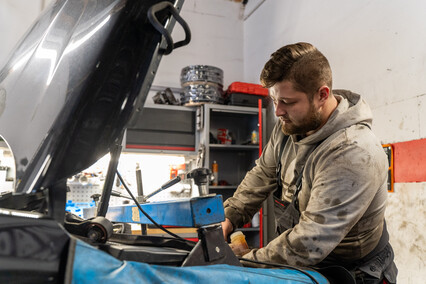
[222, 43, 397, 283]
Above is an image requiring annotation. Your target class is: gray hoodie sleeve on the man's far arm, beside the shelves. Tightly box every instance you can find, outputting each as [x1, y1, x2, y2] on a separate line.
[224, 121, 283, 228]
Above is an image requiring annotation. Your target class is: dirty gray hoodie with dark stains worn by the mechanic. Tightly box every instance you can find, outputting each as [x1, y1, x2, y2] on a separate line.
[224, 90, 388, 266]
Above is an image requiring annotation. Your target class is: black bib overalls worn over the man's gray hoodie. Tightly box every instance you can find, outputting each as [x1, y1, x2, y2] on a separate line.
[274, 136, 398, 284]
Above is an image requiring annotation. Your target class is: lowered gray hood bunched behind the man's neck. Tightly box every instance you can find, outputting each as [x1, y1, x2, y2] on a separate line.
[296, 90, 373, 145]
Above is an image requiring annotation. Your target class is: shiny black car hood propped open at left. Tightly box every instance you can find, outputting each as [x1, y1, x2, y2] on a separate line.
[0, 0, 190, 193]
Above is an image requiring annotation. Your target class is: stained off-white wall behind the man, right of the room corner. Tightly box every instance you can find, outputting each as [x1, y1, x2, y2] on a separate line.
[244, 0, 426, 283]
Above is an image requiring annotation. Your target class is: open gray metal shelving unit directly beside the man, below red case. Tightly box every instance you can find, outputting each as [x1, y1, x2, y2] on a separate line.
[200, 104, 266, 247]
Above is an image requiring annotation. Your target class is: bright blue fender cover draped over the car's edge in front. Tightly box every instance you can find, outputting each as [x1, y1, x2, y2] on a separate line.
[72, 240, 329, 284]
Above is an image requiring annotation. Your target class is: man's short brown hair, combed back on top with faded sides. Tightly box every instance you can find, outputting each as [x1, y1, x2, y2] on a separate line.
[260, 42, 332, 98]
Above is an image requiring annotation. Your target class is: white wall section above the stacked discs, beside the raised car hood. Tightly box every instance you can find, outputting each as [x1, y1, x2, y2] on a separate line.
[153, 0, 244, 89]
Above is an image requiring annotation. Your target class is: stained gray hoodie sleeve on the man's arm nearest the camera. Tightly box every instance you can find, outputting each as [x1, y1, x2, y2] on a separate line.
[244, 127, 386, 266]
